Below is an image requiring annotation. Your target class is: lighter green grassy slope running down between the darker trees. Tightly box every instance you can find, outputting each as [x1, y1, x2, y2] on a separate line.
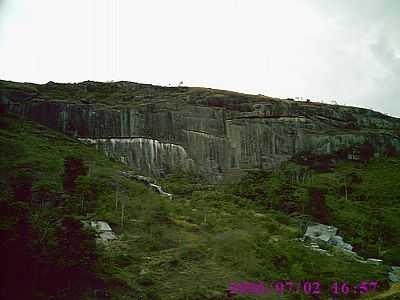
[0, 113, 396, 300]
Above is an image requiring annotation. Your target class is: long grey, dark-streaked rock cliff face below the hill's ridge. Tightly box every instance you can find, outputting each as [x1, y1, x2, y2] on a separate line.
[2, 83, 400, 181]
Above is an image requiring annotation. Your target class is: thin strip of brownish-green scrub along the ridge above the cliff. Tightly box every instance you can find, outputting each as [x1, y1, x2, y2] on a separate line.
[0, 80, 273, 111]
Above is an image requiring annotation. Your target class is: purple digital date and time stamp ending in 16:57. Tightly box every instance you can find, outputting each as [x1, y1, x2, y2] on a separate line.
[229, 280, 379, 296]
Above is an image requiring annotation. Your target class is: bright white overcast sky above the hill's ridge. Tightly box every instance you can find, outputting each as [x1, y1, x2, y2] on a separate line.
[0, 0, 400, 117]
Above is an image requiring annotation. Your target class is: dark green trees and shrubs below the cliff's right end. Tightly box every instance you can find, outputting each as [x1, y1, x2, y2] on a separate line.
[230, 157, 400, 265]
